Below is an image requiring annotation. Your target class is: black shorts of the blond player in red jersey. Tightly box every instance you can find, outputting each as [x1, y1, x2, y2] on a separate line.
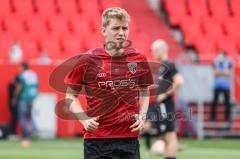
[84, 138, 140, 159]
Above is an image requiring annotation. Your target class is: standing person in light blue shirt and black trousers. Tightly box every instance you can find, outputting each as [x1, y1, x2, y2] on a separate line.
[211, 52, 233, 121]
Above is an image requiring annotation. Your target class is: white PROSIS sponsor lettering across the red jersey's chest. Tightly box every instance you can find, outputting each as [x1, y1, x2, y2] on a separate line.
[98, 79, 136, 88]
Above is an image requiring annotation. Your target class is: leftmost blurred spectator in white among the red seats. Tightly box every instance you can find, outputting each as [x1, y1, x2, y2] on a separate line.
[9, 41, 23, 63]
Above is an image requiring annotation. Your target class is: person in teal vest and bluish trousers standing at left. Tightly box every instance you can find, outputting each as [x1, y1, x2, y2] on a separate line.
[14, 63, 39, 147]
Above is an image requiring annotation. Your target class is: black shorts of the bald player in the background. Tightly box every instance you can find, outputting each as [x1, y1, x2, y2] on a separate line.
[147, 100, 176, 135]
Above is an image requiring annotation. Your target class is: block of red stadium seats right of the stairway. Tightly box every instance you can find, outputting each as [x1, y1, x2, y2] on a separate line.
[164, 0, 240, 60]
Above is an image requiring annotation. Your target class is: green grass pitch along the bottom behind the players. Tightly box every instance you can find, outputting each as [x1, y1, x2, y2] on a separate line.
[0, 138, 240, 159]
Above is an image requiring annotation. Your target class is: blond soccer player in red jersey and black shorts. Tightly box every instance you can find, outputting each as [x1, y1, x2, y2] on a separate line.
[65, 7, 153, 159]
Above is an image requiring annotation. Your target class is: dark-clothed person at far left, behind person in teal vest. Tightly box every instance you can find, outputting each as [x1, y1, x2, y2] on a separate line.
[8, 76, 18, 136]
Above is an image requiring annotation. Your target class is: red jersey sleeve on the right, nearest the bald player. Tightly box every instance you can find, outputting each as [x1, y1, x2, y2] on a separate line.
[138, 57, 154, 87]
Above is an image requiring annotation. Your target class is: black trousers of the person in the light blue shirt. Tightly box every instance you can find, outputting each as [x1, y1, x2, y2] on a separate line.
[211, 89, 231, 121]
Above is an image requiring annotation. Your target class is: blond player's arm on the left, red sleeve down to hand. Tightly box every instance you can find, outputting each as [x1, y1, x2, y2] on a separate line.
[64, 54, 101, 132]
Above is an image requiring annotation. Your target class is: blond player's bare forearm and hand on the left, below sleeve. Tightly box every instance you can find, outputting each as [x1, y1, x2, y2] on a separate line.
[66, 87, 99, 132]
